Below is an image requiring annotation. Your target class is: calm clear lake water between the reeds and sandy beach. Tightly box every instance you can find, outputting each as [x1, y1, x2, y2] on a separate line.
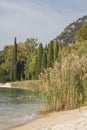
[0, 88, 41, 130]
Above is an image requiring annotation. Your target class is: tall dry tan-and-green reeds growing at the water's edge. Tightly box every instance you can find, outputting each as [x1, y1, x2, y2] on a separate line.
[40, 44, 87, 111]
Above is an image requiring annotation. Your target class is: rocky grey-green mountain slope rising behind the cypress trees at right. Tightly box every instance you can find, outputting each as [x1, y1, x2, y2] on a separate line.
[54, 15, 87, 46]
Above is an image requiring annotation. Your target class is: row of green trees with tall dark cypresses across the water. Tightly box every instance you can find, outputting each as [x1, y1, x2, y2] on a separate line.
[0, 38, 59, 82]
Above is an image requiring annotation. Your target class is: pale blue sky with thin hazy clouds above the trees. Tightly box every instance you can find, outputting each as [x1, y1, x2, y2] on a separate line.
[0, 0, 87, 50]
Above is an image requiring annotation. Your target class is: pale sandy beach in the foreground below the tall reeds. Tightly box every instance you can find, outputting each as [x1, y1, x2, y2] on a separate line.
[11, 107, 87, 130]
